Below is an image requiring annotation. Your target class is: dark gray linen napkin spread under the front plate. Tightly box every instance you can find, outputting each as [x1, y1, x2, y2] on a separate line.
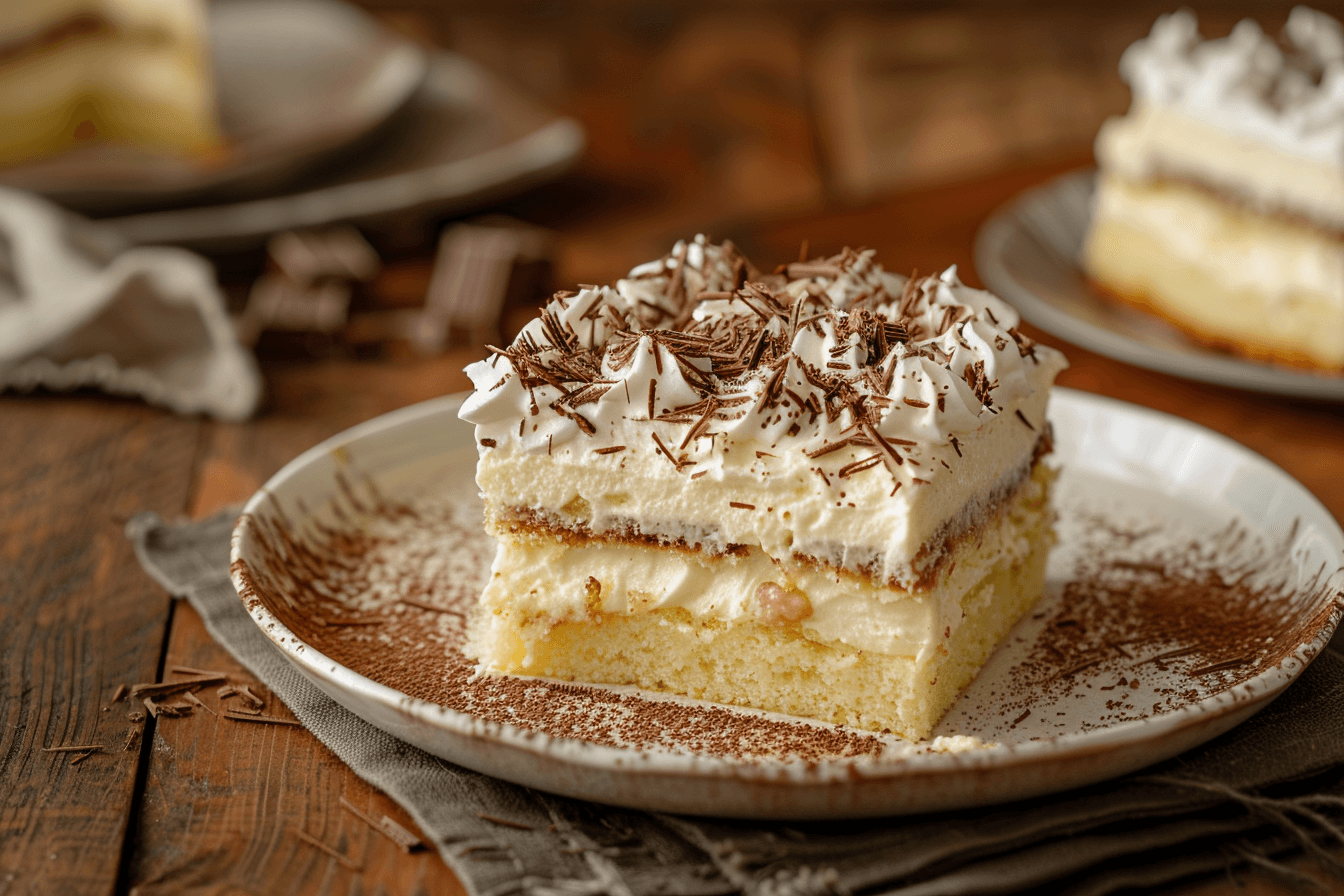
[126, 509, 1344, 896]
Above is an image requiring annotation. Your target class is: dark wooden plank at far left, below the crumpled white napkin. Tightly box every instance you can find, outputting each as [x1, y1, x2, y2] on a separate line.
[0, 395, 200, 893]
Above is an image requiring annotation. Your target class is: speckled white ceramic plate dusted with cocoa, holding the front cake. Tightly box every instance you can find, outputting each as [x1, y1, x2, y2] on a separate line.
[233, 390, 1344, 818]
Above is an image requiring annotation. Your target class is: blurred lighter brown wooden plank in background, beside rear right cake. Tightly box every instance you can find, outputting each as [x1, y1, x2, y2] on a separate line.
[808, 7, 1134, 199]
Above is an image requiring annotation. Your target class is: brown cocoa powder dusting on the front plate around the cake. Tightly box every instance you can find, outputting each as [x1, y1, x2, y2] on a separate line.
[245, 480, 1339, 762]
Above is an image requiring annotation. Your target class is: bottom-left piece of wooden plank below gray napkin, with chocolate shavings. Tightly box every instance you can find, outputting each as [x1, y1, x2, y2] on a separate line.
[126, 603, 465, 896]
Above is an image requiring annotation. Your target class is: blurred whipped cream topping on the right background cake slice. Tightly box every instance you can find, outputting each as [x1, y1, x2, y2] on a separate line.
[1120, 7, 1344, 169]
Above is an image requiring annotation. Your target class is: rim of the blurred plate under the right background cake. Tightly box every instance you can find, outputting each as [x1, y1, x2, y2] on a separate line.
[973, 168, 1344, 402]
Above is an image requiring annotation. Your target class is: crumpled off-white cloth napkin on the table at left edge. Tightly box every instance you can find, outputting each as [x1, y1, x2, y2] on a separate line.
[0, 188, 262, 420]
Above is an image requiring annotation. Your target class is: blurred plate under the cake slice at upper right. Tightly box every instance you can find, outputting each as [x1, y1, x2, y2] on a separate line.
[976, 171, 1344, 402]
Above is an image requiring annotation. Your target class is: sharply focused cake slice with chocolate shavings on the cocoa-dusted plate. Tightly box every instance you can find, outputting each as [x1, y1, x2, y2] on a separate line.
[461, 236, 1064, 739]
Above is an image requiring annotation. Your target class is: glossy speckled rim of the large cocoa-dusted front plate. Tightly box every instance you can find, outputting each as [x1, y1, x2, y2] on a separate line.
[230, 387, 1344, 817]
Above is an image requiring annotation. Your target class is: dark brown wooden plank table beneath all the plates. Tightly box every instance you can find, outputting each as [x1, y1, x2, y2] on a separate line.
[0, 4, 1344, 896]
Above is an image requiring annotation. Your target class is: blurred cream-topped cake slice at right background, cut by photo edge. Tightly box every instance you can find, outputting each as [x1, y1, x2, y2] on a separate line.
[1083, 7, 1344, 372]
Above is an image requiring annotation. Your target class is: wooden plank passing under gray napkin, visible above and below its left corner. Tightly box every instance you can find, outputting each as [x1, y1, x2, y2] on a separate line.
[128, 349, 482, 896]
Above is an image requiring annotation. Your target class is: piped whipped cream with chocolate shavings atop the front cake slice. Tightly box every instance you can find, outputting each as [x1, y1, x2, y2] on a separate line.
[461, 235, 1064, 478]
